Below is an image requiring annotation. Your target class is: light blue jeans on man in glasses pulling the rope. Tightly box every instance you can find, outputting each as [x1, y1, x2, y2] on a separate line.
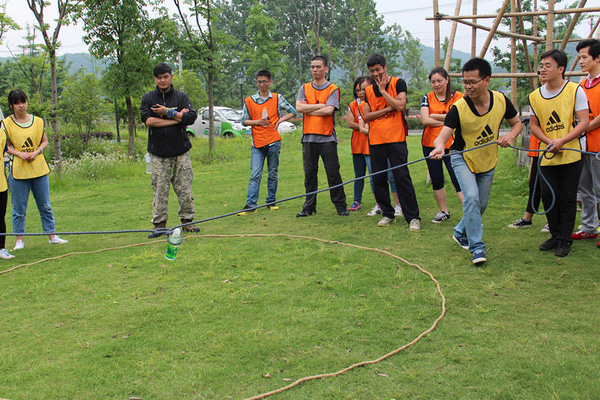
[450, 153, 494, 253]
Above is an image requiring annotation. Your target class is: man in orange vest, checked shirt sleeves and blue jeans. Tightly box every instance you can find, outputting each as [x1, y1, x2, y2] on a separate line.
[238, 69, 298, 215]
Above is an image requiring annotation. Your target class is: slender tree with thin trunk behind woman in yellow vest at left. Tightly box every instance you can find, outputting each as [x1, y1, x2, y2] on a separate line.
[27, 0, 81, 178]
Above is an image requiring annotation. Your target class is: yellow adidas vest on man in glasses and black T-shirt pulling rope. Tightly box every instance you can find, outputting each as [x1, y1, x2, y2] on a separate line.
[454, 91, 506, 174]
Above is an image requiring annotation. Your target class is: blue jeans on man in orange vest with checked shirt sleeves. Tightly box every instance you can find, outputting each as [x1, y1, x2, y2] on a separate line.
[246, 141, 281, 207]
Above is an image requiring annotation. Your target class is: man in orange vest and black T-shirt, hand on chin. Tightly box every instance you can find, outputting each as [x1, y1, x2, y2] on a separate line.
[364, 54, 421, 231]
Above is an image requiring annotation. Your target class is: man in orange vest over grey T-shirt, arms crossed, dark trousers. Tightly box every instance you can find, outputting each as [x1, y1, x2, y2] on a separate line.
[296, 56, 349, 218]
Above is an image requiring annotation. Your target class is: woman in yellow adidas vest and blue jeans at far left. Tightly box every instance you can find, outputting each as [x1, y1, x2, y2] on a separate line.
[2, 89, 68, 250]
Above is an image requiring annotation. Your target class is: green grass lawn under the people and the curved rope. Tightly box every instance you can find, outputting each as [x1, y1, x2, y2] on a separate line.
[0, 131, 600, 400]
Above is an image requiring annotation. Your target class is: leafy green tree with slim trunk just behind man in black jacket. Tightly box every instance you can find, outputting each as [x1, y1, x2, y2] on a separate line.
[82, 0, 174, 157]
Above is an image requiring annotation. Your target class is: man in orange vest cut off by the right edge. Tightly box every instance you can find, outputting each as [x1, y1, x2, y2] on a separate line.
[571, 39, 600, 248]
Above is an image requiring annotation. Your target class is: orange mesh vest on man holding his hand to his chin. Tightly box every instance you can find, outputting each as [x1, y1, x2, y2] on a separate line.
[366, 76, 407, 144]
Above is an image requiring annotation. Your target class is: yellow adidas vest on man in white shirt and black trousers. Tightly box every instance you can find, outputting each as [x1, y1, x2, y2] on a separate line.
[529, 82, 581, 166]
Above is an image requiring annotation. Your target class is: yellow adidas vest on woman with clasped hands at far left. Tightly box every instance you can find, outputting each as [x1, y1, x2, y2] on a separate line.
[2, 116, 50, 179]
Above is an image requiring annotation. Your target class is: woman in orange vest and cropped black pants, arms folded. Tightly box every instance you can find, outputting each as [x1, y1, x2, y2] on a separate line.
[421, 67, 463, 224]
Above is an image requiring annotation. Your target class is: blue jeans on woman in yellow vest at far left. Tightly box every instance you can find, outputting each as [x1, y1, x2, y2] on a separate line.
[8, 169, 56, 234]
